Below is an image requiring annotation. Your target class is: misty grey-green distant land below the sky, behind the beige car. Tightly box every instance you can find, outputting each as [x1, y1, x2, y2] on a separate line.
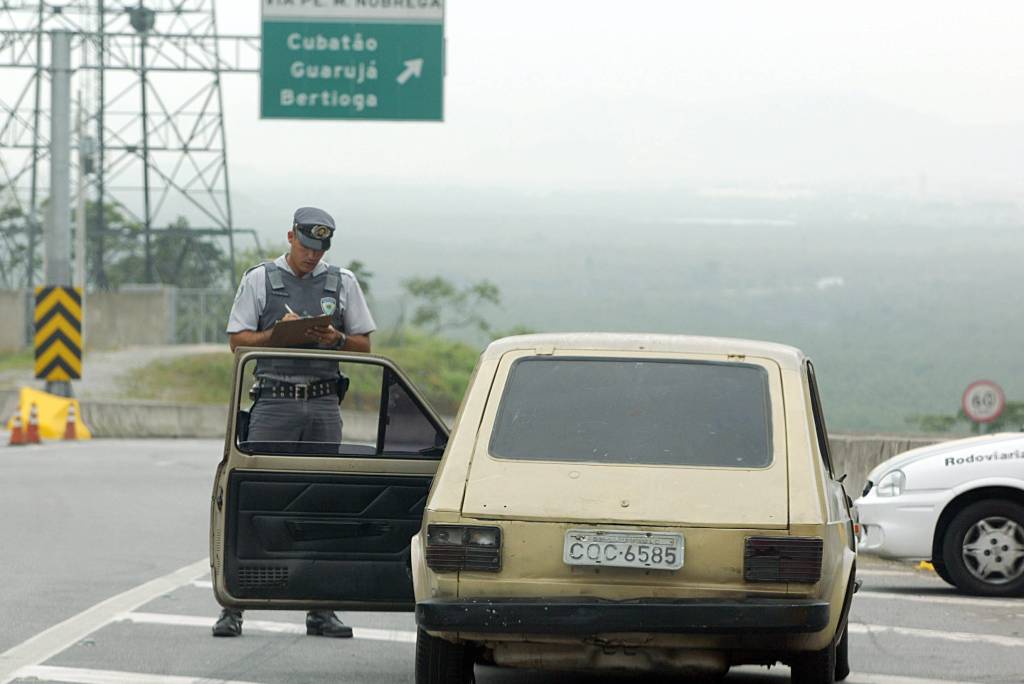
[339, 198, 1024, 432]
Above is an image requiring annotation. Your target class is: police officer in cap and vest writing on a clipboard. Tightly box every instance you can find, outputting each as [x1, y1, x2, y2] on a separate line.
[213, 207, 377, 637]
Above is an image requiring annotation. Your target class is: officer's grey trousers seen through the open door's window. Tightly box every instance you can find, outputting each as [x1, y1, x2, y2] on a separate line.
[249, 395, 341, 444]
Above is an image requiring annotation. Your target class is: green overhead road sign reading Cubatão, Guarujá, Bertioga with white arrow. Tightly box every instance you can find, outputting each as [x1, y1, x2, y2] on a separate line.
[260, 0, 444, 121]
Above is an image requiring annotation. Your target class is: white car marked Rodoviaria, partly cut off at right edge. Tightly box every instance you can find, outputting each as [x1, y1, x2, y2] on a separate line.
[855, 432, 1024, 596]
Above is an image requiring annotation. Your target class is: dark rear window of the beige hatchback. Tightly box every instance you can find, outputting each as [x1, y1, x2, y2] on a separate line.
[489, 356, 772, 468]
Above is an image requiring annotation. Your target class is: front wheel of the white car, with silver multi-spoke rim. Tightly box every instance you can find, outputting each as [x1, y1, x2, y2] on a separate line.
[942, 499, 1024, 596]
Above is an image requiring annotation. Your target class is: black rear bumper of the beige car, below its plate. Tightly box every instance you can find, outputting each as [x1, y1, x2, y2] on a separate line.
[416, 598, 829, 635]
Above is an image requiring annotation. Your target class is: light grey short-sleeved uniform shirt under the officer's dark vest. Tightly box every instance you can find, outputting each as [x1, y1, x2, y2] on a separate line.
[226, 255, 377, 382]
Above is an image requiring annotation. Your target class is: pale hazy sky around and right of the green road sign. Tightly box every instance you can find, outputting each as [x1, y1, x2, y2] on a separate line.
[211, 0, 1024, 202]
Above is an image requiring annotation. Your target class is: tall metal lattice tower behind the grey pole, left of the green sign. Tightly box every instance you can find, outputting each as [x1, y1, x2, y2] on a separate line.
[0, 0, 259, 288]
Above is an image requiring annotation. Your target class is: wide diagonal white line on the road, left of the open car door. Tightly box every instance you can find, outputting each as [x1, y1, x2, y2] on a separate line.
[0, 558, 210, 684]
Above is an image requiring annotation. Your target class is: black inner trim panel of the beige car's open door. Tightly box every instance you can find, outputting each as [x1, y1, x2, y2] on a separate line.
[224, 471, 431, 603]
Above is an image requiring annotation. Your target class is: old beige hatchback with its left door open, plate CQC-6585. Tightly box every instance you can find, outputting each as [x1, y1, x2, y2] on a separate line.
[211, 334, 856, 683]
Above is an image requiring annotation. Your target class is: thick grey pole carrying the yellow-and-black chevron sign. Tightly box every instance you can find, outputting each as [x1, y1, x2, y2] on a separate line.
[44, 31, 72, 396]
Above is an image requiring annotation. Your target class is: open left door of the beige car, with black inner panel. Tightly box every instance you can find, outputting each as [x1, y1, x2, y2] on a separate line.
[210, 348, 449, 610]
